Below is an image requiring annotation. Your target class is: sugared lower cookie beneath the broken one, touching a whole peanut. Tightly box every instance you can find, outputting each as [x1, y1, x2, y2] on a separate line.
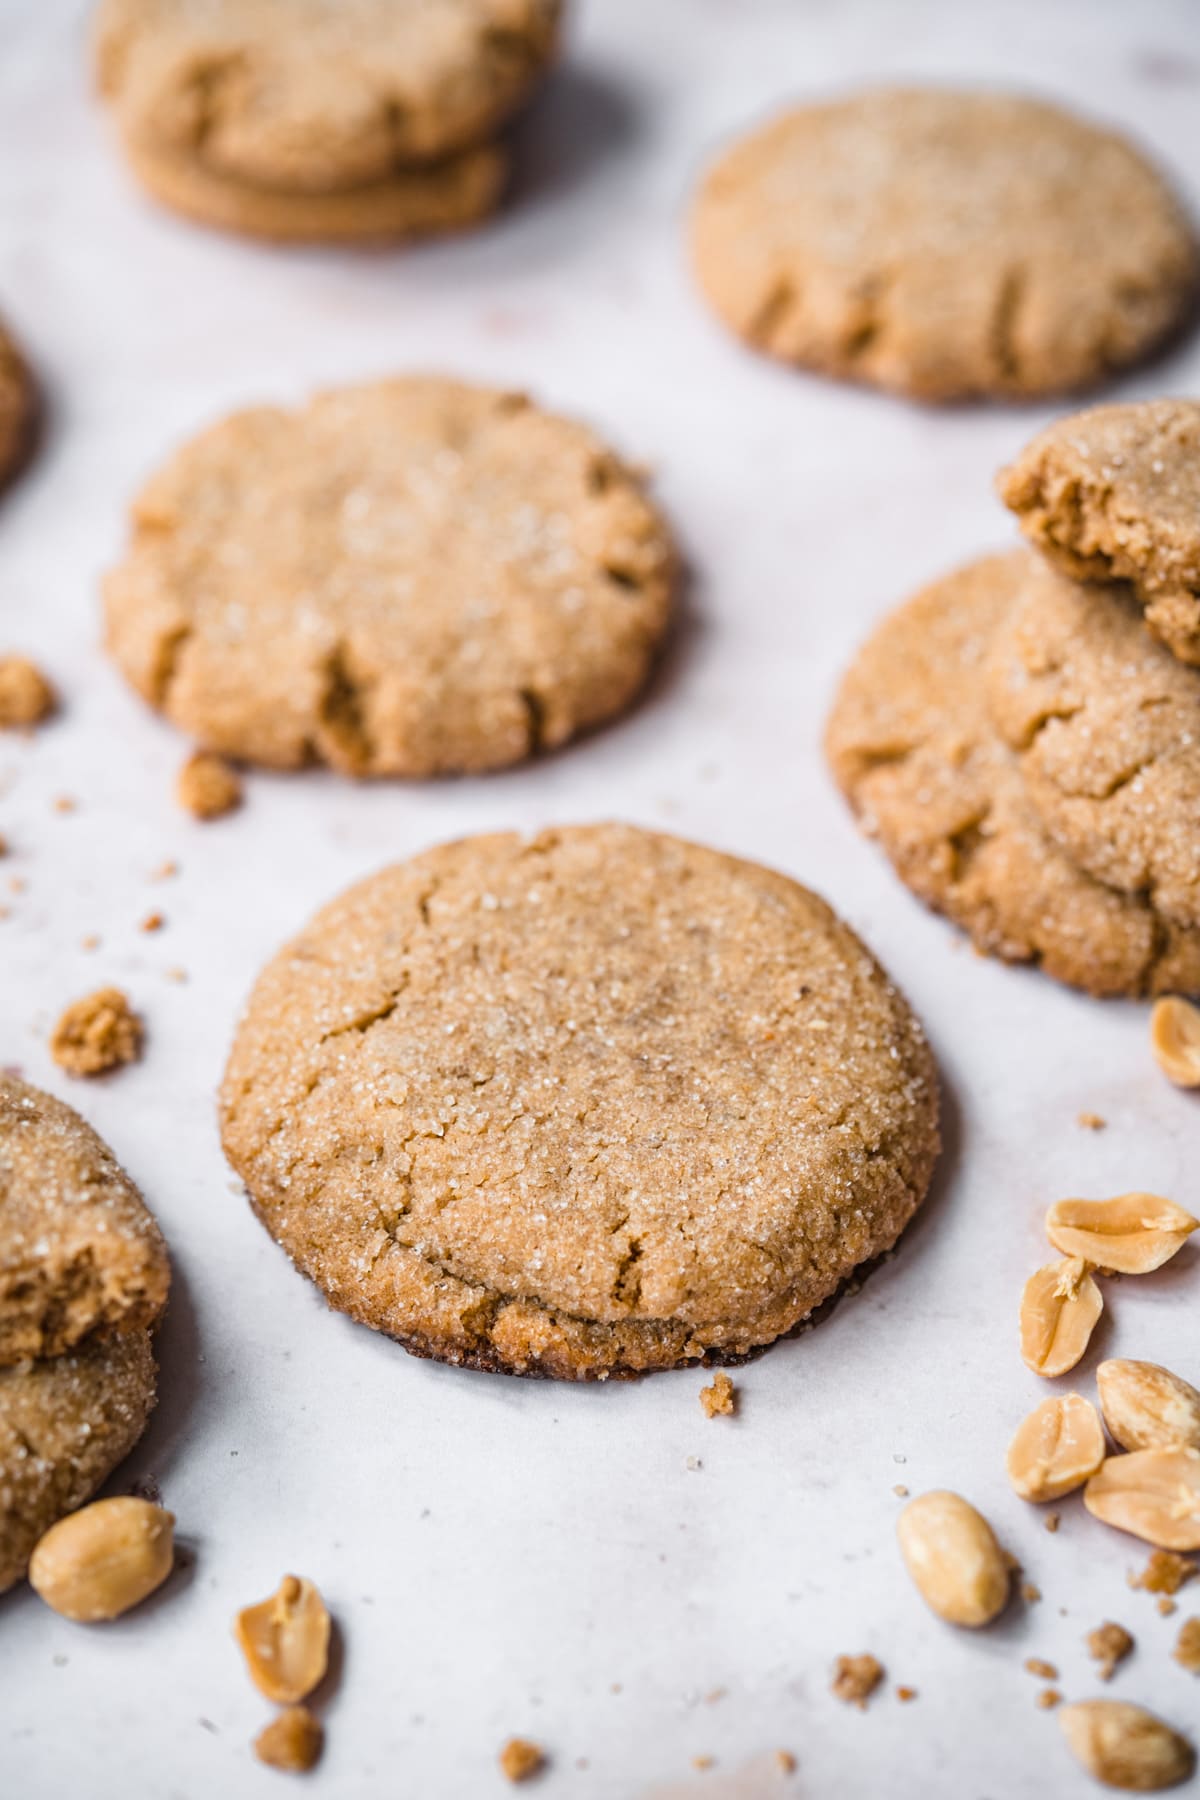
[0, 1328, 155, 1593]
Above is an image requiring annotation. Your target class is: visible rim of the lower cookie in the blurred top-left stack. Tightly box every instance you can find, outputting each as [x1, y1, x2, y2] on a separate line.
[126, 131, 509, 245]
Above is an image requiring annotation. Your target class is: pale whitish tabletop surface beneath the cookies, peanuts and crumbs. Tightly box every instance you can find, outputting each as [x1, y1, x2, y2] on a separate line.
[0, 0, 1200, 1800]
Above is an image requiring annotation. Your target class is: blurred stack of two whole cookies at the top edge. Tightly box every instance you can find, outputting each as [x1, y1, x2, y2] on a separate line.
[95, 0, 561, 243]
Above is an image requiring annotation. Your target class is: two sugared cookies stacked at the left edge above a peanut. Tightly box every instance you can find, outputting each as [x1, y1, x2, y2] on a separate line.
[0, 1075, 171, 1593]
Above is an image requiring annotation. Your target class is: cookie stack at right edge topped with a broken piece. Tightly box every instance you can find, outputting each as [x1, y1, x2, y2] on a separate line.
[826, 401, 1200, 995]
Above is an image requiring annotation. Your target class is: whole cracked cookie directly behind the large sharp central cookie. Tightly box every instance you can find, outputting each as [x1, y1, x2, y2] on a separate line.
[106, 378, 675, 776]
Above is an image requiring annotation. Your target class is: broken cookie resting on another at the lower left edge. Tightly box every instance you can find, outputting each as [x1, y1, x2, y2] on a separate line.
[0, 1075, 171, 1364]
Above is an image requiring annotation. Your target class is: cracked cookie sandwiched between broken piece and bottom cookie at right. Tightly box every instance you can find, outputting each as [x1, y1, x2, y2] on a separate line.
[988, 558, 1200, 929]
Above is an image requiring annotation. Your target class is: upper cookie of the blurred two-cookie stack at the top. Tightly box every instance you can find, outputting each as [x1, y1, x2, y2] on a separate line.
[95, 0, 561, 182]
